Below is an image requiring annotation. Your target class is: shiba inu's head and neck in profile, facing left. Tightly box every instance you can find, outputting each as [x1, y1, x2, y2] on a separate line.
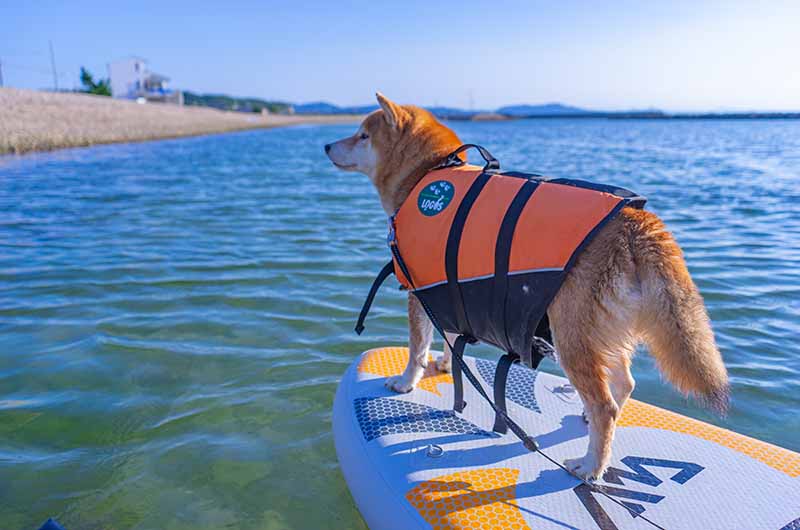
[325, 93, 461, 213]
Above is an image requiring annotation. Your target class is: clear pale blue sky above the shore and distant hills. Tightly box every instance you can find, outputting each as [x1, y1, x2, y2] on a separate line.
[0, 0, 800, 111]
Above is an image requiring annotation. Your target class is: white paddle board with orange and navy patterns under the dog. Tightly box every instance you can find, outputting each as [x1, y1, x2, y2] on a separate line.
[333, 347, 800, 530]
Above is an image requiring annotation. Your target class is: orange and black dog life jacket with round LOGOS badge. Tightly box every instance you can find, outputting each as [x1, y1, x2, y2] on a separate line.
[357, 145, 645, 365]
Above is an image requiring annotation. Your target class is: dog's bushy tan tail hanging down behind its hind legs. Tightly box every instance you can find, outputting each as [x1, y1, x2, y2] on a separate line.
[631, 211, 730, 415]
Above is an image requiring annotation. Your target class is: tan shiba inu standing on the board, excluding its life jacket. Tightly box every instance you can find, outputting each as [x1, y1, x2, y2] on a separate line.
[325, 94, 729, 480]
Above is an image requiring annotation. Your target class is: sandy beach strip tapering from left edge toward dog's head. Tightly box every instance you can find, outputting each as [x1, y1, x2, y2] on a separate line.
[0, 88, 361, 154]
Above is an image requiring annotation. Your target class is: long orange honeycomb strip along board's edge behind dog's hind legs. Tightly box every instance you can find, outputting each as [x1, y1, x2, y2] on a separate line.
[617, 399, 800, 477]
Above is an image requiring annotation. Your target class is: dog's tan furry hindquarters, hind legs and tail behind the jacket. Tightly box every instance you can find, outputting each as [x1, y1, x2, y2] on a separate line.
[547, 208, 728, 477]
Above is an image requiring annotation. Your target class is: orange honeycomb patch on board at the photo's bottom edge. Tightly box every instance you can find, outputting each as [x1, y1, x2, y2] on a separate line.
[406, 468, 530, 530]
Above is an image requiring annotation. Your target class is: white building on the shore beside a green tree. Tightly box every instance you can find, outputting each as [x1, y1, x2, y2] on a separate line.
[108, 57, 183, 105]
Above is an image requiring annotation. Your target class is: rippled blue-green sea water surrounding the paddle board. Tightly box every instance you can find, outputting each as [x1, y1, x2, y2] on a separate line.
[0, 120, 800, 530]
